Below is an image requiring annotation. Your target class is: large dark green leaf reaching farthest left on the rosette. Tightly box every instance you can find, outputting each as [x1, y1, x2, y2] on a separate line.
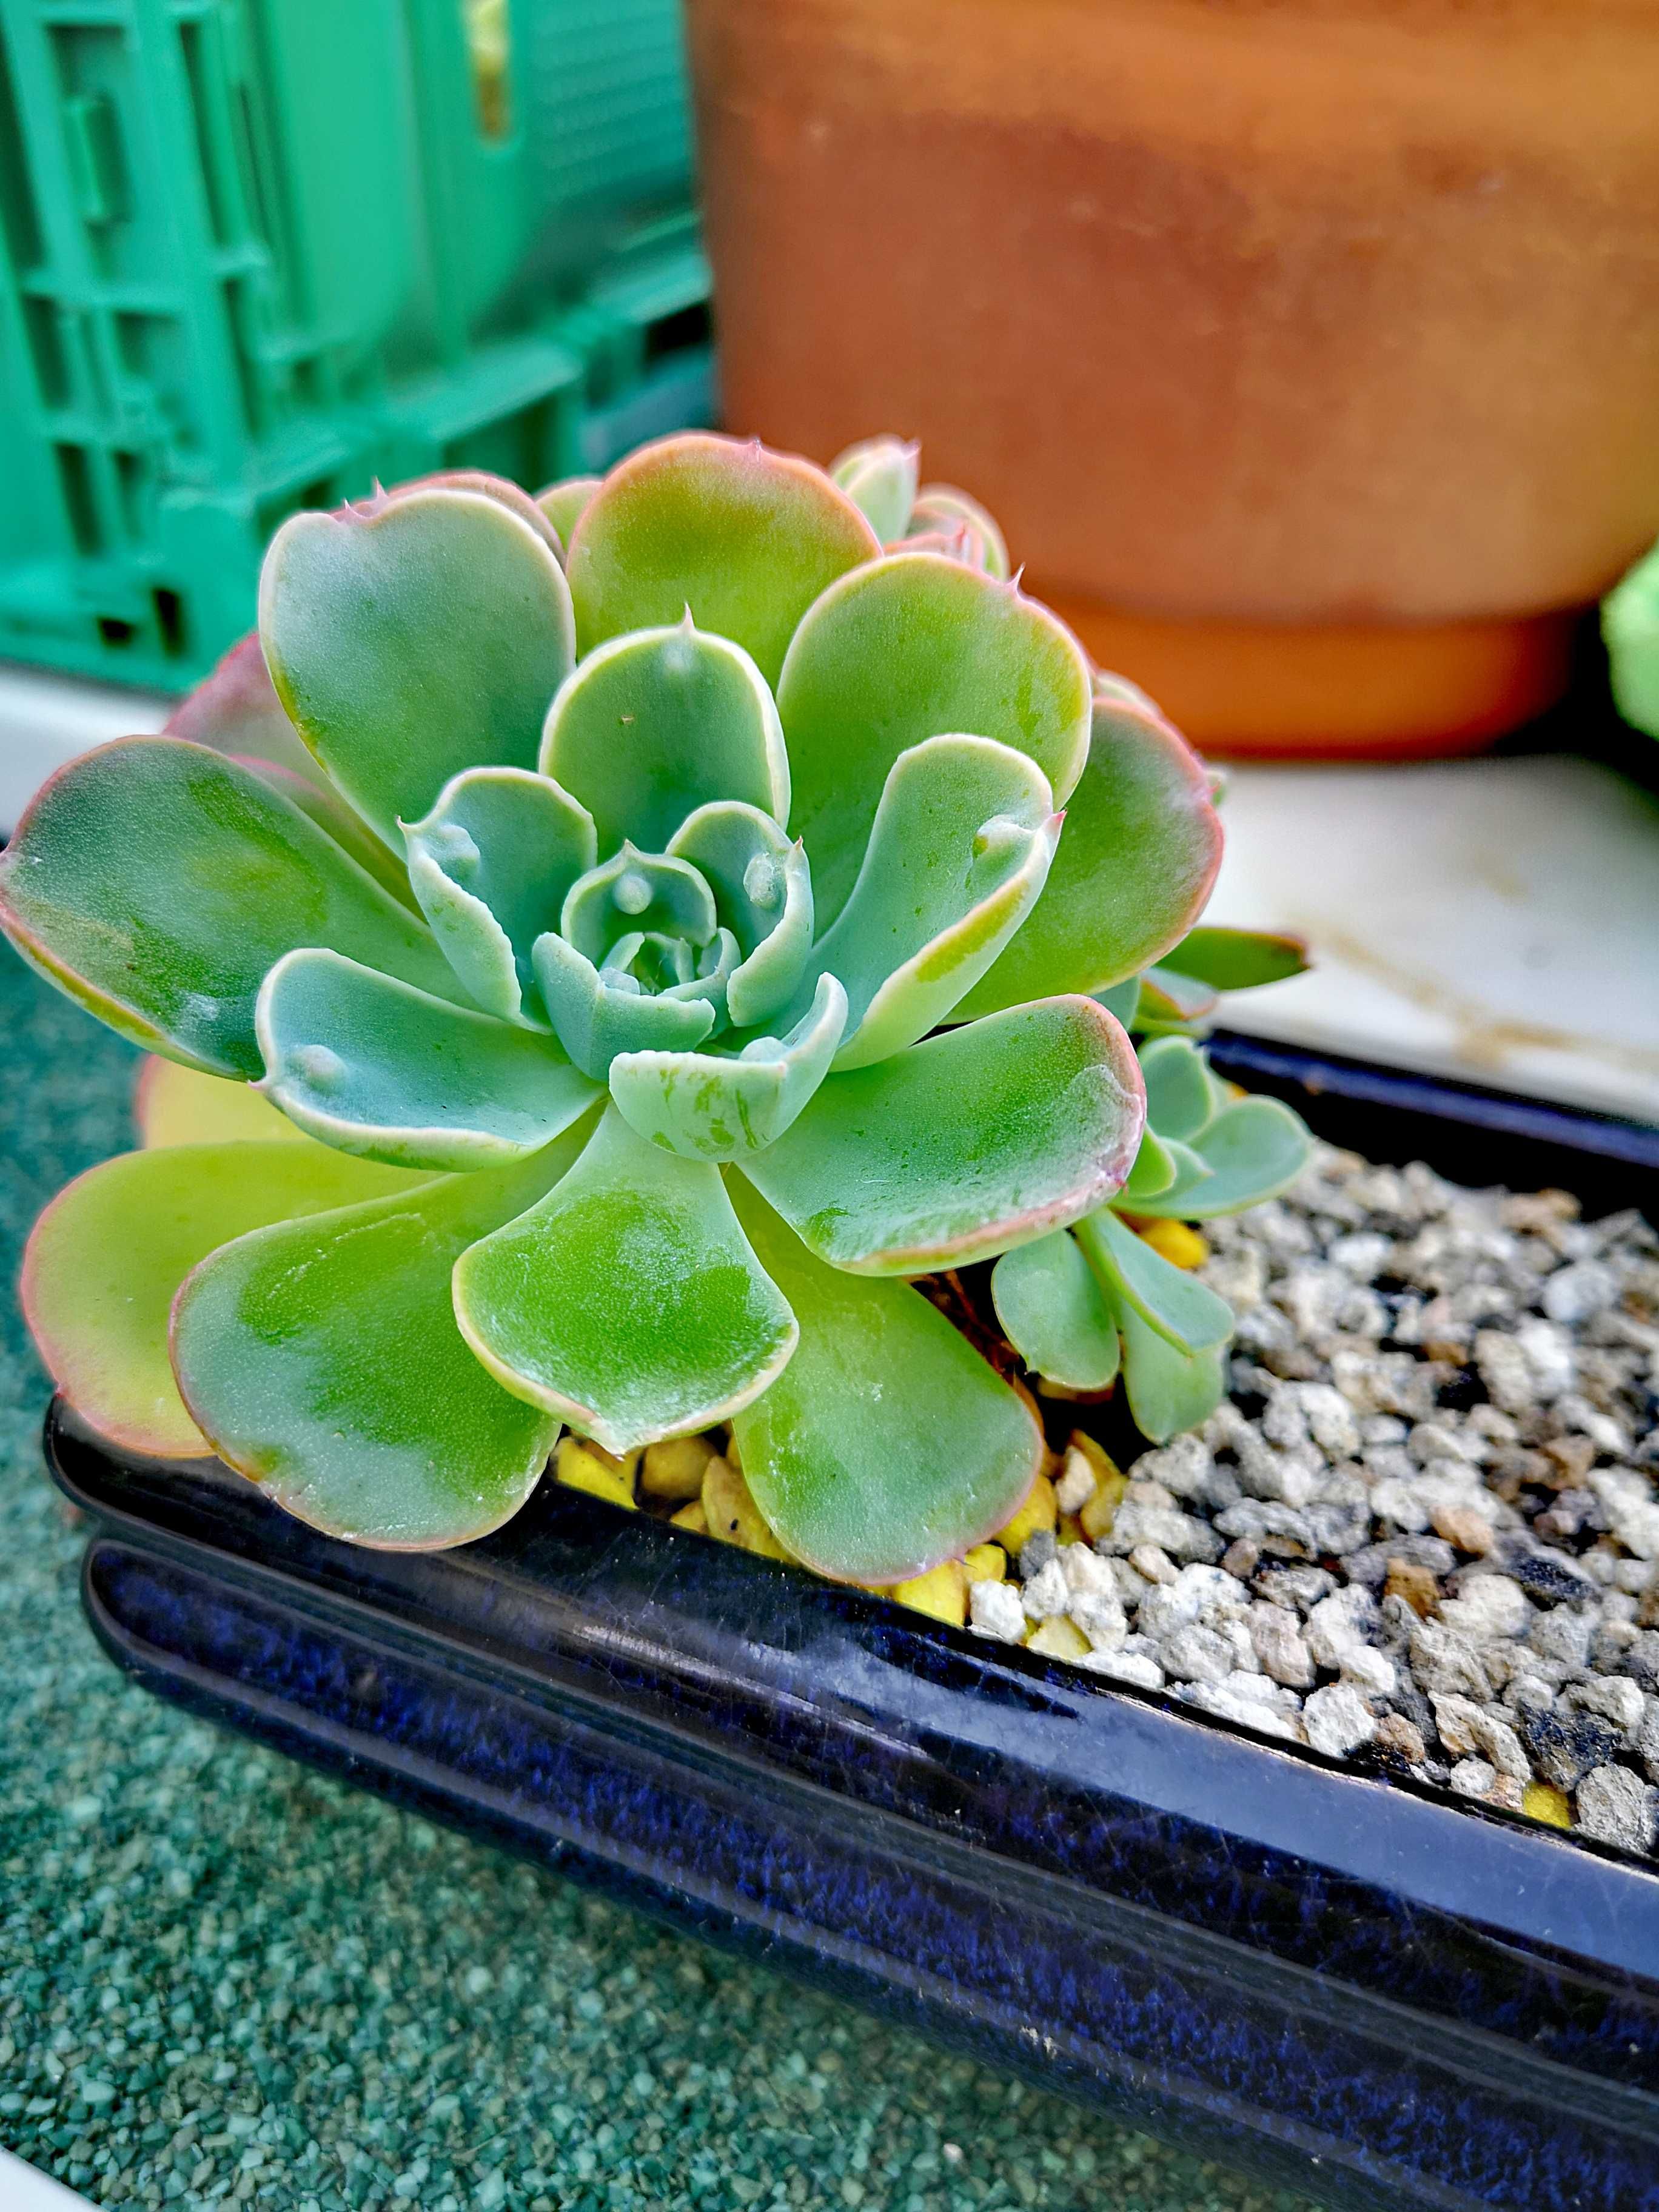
[0, 737, 460, 1075]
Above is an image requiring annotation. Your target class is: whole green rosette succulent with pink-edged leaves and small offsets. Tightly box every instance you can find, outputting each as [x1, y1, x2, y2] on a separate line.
[0, 422, 1301, 1584]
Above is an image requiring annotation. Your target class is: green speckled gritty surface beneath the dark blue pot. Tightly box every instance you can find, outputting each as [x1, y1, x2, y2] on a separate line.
[0, 947, 1327, 2212]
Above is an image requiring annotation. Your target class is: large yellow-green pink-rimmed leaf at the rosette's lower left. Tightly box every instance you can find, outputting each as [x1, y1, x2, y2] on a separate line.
[20, 1141, 420, 1458]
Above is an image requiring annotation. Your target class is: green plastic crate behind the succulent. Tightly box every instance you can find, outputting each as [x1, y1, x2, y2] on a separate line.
[0, 0, 712, 688]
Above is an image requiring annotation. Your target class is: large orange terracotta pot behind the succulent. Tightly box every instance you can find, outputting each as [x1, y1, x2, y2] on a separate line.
[688, 0, 1659, 750]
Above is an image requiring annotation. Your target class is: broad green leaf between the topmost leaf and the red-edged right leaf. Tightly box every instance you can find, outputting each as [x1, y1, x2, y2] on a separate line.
[779, 553, 1090, 933]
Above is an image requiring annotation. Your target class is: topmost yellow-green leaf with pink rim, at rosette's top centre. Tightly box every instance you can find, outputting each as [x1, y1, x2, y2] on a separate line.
[566, 434, 880, 683]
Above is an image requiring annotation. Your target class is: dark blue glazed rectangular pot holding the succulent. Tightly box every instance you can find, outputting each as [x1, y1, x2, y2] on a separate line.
[47, 1040, 1659, 2212]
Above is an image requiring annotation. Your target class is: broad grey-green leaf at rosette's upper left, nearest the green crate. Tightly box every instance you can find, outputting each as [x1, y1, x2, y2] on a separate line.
[259, 484, 575, 851]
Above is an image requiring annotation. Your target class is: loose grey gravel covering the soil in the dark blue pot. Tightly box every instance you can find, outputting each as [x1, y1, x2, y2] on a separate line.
[987, 1146, 1659, 1854]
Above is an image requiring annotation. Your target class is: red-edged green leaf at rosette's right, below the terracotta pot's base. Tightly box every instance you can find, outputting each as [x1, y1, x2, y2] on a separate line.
[960, 697, 1221, 1017]
